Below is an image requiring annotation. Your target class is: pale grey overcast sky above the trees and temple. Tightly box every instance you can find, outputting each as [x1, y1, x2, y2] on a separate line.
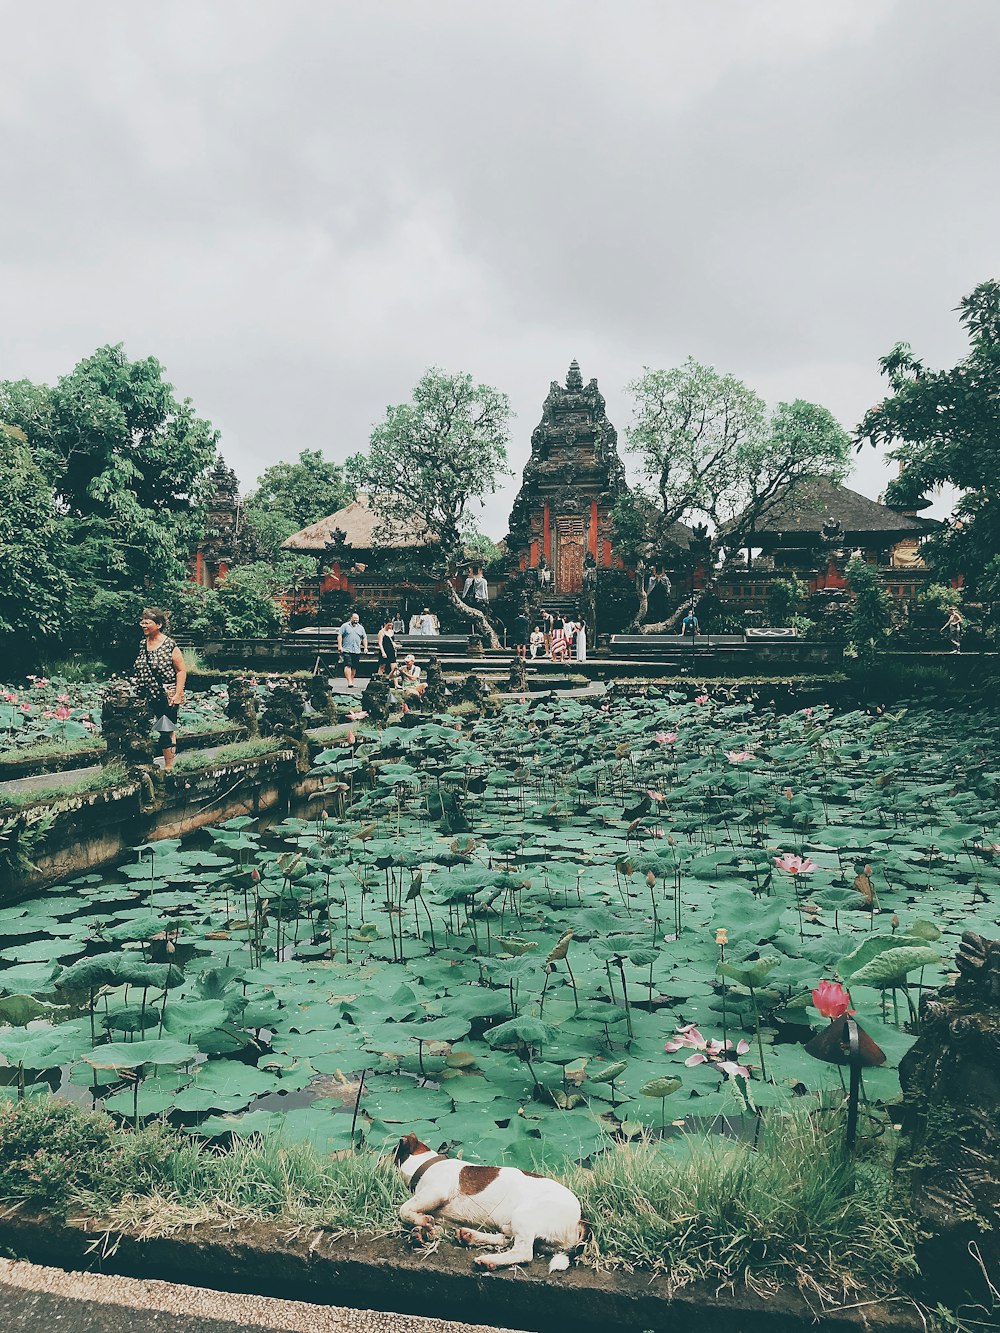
[0, 0, 1000, 539]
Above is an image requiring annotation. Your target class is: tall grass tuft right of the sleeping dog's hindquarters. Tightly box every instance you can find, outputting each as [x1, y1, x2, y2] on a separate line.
[568, 1113, 916, 1298]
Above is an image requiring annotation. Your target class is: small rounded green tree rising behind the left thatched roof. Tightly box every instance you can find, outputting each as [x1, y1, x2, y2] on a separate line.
[247, 449, 355, 559]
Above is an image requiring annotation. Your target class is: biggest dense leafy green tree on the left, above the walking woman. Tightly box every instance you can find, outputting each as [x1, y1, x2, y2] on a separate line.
[0, 345, 217, 648]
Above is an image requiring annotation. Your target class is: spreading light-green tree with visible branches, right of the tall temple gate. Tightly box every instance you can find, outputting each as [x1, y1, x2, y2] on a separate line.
[623, 357, 851, 632]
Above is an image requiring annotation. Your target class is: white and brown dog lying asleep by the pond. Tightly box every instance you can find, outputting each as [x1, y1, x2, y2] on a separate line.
[396, 1134, 589, 1273]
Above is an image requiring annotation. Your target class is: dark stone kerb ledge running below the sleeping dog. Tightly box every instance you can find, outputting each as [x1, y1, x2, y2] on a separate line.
[0, 1210, 925, 1333]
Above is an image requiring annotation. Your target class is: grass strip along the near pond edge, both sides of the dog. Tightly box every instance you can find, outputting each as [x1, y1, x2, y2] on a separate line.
[0, 1097, 916, 1300]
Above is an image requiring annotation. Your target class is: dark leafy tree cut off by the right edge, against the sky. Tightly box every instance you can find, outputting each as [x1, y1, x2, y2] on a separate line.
[857, 280, 1000, 599]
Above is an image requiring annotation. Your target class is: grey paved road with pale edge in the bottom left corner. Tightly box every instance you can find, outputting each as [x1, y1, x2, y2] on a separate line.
[0, 1260, 528, 1333]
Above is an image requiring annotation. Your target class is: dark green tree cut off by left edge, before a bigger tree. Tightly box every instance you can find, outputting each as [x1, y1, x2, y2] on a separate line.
[0, 423, 68, 670]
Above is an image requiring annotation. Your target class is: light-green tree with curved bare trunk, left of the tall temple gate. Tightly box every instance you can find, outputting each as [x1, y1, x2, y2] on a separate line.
[349, 368, 511, 648]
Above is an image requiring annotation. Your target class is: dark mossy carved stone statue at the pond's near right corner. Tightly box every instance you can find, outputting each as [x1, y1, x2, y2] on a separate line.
[899, 930, 1000, 1305]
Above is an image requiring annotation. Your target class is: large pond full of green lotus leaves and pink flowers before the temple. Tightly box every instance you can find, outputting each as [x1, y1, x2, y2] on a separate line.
[0, 689, 1000, 1165]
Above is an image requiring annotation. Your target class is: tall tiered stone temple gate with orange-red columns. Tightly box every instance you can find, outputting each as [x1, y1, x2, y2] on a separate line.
[507, 361, 625, 595]
